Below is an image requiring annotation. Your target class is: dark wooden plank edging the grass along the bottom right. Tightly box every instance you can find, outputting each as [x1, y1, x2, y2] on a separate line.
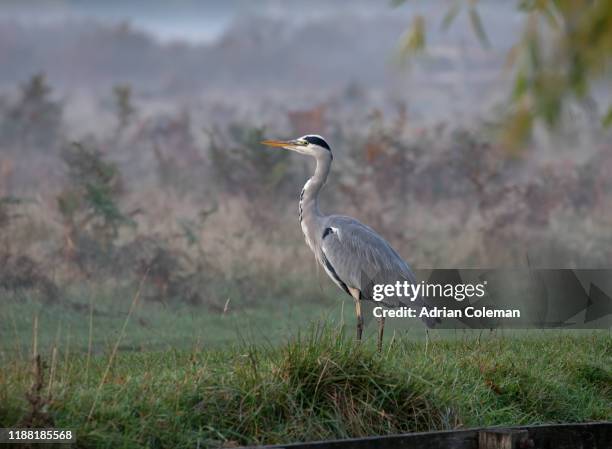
[244, 422, 612, 449]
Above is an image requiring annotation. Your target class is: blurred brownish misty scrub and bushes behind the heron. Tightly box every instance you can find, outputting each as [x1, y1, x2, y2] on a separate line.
[0, 73, 612, 328]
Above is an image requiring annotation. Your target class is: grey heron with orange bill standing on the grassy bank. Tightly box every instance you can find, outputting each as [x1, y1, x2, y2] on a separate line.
[262, 134, 438, 350]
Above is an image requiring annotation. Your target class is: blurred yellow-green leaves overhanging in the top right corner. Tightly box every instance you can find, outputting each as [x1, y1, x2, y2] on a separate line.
[394, 0, 612, 148]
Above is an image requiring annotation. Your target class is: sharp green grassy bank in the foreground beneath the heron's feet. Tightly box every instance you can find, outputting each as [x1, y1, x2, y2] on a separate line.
[0, 328, 612, 448]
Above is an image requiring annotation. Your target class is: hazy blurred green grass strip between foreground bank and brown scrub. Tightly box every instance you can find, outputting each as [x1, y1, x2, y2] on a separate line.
[0, 285, 354, 361]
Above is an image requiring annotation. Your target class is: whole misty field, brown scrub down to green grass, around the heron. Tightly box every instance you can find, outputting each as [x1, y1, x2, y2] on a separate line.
[0, 65, 612, 448]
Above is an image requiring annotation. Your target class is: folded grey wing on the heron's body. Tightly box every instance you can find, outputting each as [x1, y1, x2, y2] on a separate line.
[320, 215, 434, 327]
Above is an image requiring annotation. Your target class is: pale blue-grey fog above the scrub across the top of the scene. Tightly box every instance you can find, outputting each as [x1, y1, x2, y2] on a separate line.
[0, 0, 521, 118]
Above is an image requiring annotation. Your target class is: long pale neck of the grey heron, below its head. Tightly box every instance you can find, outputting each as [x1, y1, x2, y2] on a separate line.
[299, 153, 332, 248]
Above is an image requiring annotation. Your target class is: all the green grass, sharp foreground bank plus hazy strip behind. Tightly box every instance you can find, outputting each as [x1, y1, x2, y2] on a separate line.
[0, 284, 612, 448]
